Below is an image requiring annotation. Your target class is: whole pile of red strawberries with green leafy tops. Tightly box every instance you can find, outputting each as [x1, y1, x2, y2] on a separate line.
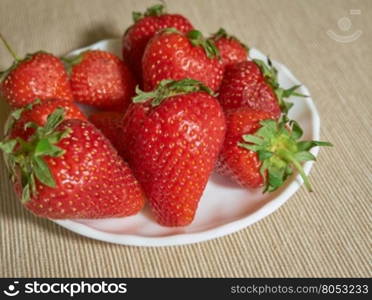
[0, 5, 330, 226]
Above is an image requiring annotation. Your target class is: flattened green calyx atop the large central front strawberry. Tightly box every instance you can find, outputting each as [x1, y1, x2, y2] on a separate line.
[132, 78, 215, 107]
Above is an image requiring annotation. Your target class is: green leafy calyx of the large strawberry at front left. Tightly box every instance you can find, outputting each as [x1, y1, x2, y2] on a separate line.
[0, 108, 71, 203]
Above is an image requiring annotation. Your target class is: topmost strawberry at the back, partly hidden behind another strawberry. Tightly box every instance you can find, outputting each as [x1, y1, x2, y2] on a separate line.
[123, 4, 193, 79]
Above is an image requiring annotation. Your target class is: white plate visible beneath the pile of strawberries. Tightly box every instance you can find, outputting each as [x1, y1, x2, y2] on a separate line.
[54, 39, 320, 246]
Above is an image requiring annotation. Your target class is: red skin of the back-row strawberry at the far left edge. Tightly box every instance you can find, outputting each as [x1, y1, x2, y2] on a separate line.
[0, 52, 73, 108]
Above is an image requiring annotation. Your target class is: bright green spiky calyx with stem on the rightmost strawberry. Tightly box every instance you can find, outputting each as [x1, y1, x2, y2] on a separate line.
[238, 120, 332, 193]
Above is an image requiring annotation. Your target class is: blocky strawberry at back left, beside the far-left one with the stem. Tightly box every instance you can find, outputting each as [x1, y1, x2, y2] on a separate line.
[66, 50, 136, 111]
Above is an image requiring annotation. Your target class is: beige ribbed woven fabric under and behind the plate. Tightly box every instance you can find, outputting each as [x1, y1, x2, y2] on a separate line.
[0, 0, 372, 277]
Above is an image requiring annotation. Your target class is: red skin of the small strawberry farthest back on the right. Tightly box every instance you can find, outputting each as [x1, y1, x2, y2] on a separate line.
[215, 37, 248, 67]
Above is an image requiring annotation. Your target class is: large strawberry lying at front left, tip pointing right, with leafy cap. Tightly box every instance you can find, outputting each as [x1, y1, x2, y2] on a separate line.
[0, 108, 144, 219]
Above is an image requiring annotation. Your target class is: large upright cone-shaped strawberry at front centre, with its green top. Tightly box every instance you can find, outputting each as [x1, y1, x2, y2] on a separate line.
[123, 79, 225, 226]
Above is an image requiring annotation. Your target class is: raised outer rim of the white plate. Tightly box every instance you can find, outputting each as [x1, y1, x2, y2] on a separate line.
[51, 39, 320, 247]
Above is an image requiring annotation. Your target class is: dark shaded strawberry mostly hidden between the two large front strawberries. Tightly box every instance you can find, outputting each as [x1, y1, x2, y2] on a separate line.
[89, 111, 123, 153]
